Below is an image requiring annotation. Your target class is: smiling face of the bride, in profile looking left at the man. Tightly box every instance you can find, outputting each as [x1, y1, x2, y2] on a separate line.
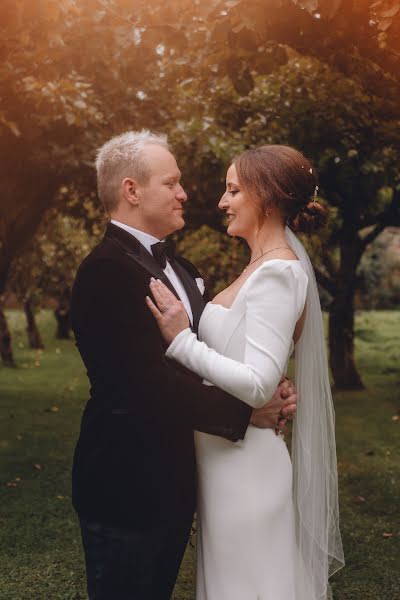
[218, 165, 260, 240]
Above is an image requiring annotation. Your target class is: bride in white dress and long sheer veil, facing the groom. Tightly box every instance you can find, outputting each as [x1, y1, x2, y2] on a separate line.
[147, 145, 344, 600]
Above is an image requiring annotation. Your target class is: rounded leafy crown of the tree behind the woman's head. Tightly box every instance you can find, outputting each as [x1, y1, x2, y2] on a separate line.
[202, 55, 400, 212]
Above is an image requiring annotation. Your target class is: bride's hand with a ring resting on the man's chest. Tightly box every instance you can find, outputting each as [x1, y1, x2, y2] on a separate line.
[146, 277, 190, 344]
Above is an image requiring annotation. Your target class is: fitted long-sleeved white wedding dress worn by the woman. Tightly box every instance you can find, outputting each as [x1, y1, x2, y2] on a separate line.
[167, 259, 315, 600]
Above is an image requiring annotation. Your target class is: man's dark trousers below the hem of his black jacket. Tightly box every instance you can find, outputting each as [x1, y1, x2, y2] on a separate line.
[80, 512, 193, 600]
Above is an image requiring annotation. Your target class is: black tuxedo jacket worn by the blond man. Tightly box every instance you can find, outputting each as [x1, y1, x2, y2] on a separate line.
[72, 224, 251, 528]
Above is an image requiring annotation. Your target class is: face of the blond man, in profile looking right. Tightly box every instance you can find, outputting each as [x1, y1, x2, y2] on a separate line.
[137, 144, 187, 239]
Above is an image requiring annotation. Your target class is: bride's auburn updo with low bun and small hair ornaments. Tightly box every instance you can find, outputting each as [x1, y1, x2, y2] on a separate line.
[233, 145, 327, 233]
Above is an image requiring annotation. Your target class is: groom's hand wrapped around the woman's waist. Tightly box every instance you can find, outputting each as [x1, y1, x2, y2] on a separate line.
[250, 378, 297, 431]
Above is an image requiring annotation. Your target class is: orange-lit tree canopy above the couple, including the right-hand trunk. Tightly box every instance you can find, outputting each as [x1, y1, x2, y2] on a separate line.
[0, 0, 400, 385]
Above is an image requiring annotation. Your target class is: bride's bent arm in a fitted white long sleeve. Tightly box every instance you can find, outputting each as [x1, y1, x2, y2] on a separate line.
[147, 262, 306, 408]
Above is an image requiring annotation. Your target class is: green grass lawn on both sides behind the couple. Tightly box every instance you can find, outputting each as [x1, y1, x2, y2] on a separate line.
[0, 311, 400, 600]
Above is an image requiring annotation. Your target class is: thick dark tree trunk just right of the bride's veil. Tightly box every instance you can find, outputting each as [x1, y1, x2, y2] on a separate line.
[329, 230, 364, 390]
